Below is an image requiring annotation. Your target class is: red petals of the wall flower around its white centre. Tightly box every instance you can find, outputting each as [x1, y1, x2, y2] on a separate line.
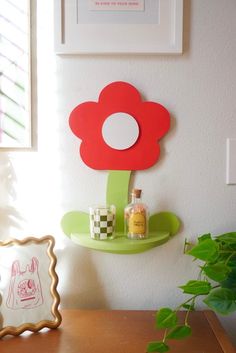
[69, 81, 170, 170]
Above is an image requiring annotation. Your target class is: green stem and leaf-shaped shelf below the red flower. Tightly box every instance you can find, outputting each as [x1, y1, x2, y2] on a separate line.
[61, 170, 180, 254]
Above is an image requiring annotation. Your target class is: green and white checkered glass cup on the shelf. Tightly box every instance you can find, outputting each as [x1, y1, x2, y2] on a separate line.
[89, 205, 116, 240]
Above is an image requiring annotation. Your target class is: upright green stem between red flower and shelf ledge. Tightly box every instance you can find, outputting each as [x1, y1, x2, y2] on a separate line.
[106, 170, 131, 234]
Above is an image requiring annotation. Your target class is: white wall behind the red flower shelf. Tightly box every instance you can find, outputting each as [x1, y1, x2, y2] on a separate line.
[0, 0, 236, 342]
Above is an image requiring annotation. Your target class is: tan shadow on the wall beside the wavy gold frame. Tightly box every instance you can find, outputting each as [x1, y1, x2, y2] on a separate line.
[57, 240, 108, 309]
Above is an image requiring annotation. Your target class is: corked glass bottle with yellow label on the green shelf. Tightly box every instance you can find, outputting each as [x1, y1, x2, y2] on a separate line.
[124, 189, 148, 239]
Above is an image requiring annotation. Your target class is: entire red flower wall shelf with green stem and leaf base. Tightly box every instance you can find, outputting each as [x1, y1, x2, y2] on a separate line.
[61, 81, 180, 254]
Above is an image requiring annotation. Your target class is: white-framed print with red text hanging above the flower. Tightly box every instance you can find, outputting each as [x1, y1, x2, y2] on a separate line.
[54, 0, 183, 54]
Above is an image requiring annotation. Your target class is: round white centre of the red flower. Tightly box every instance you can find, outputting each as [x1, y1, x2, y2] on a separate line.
[102, 113, 139, 150]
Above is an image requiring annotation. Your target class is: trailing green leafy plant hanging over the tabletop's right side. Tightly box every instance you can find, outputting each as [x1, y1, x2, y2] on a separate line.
[147, 232, 236, 353]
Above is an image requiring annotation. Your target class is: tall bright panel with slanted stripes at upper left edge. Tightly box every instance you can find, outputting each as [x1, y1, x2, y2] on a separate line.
[0, 0, 31, 148]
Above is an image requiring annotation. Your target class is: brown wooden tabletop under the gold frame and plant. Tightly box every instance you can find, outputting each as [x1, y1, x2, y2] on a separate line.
[0, 310, 236, 353]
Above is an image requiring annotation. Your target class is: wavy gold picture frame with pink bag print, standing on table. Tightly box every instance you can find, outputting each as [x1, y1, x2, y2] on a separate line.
[0, 235, 61, 338]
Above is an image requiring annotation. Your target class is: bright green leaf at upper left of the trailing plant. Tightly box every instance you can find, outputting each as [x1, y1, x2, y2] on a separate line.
[187, 239, 219, 261]
